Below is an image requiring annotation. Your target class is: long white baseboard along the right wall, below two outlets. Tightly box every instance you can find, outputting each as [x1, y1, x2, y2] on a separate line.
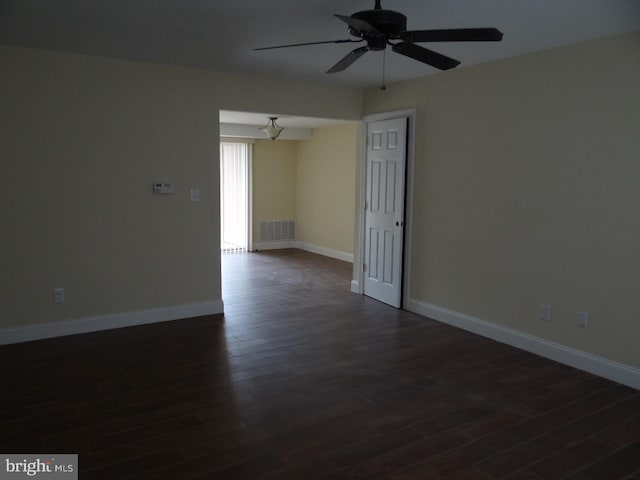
[405, 299, 640, 389]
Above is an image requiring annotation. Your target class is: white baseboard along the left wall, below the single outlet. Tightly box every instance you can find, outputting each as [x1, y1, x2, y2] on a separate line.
[0, 300, 224, 345]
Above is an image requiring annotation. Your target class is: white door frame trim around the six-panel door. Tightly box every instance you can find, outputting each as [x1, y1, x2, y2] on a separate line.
[351, 108, 416, 308]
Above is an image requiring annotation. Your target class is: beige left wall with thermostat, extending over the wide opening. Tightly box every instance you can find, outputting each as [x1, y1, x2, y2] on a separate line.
[0, 47, 362, 328]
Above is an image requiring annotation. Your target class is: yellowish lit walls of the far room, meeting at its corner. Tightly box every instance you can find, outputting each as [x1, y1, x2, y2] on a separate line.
[253, 123, 360, 258]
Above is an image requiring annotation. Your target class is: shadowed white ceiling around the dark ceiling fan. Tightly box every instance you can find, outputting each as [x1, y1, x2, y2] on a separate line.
[0, 0, 640, 127]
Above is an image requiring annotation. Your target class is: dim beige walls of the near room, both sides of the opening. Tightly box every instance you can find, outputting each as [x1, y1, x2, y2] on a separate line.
[5, 33, 640, 376]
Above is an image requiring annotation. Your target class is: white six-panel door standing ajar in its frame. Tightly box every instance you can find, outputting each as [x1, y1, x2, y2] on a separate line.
[364, 118, 407, 307]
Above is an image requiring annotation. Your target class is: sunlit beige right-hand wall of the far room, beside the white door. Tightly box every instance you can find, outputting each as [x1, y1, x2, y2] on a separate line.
[296, 123, 360, 255]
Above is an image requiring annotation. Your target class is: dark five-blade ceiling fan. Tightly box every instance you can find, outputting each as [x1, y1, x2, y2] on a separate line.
[254, 0, 502, 73]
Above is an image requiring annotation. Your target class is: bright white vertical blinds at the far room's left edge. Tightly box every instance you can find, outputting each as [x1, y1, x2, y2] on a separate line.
[220, 142, 251, 253]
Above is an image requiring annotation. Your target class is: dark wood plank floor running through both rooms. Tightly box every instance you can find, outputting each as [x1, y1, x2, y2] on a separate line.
[0, 250, 640, 480]
